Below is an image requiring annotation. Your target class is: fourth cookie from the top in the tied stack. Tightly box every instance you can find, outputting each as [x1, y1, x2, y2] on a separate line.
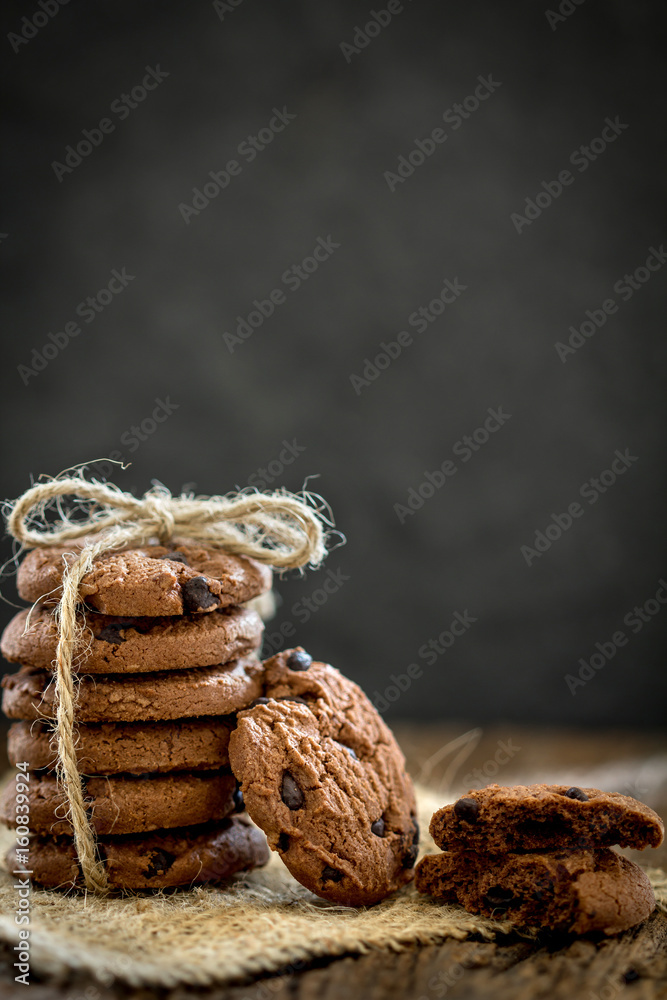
[7, 716, 236, 775]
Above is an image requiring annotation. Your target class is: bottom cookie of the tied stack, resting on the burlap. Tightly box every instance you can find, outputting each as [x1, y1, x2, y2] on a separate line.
[7, 816, 269, 889]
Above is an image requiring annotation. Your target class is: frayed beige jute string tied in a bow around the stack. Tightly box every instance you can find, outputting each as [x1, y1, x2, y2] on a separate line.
[6, 470, 331, 895]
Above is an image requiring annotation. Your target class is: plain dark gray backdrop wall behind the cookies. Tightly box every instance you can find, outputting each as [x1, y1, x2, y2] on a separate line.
[0, 0, 665, 726]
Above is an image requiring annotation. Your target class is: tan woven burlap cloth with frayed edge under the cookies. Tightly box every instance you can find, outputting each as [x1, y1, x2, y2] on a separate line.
[0, 788, 667, 987]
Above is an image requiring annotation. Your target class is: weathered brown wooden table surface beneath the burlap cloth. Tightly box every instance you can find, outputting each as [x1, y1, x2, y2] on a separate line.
[0, 723, 667, 1000]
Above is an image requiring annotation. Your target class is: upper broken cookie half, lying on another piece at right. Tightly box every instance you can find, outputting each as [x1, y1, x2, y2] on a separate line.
[430, 785, 664, 854]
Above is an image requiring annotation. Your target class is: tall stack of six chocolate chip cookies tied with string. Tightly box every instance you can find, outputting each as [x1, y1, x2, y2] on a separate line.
[0, 543, 271, 889]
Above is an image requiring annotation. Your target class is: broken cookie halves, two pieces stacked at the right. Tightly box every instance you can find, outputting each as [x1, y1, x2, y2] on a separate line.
[416, 785, 664, 934]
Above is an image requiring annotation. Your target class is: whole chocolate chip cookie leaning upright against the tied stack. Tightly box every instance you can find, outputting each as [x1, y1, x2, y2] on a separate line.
[229, 649, 419, 906]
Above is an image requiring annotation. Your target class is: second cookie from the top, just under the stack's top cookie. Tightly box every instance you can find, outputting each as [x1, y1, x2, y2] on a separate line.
[0, 604, 263, 674]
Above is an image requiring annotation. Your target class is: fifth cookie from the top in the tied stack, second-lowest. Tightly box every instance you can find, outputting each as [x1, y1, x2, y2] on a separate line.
[0, 772, 237, 836]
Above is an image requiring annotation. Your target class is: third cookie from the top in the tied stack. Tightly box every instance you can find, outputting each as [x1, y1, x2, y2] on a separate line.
[2, 655, 262, 723]
